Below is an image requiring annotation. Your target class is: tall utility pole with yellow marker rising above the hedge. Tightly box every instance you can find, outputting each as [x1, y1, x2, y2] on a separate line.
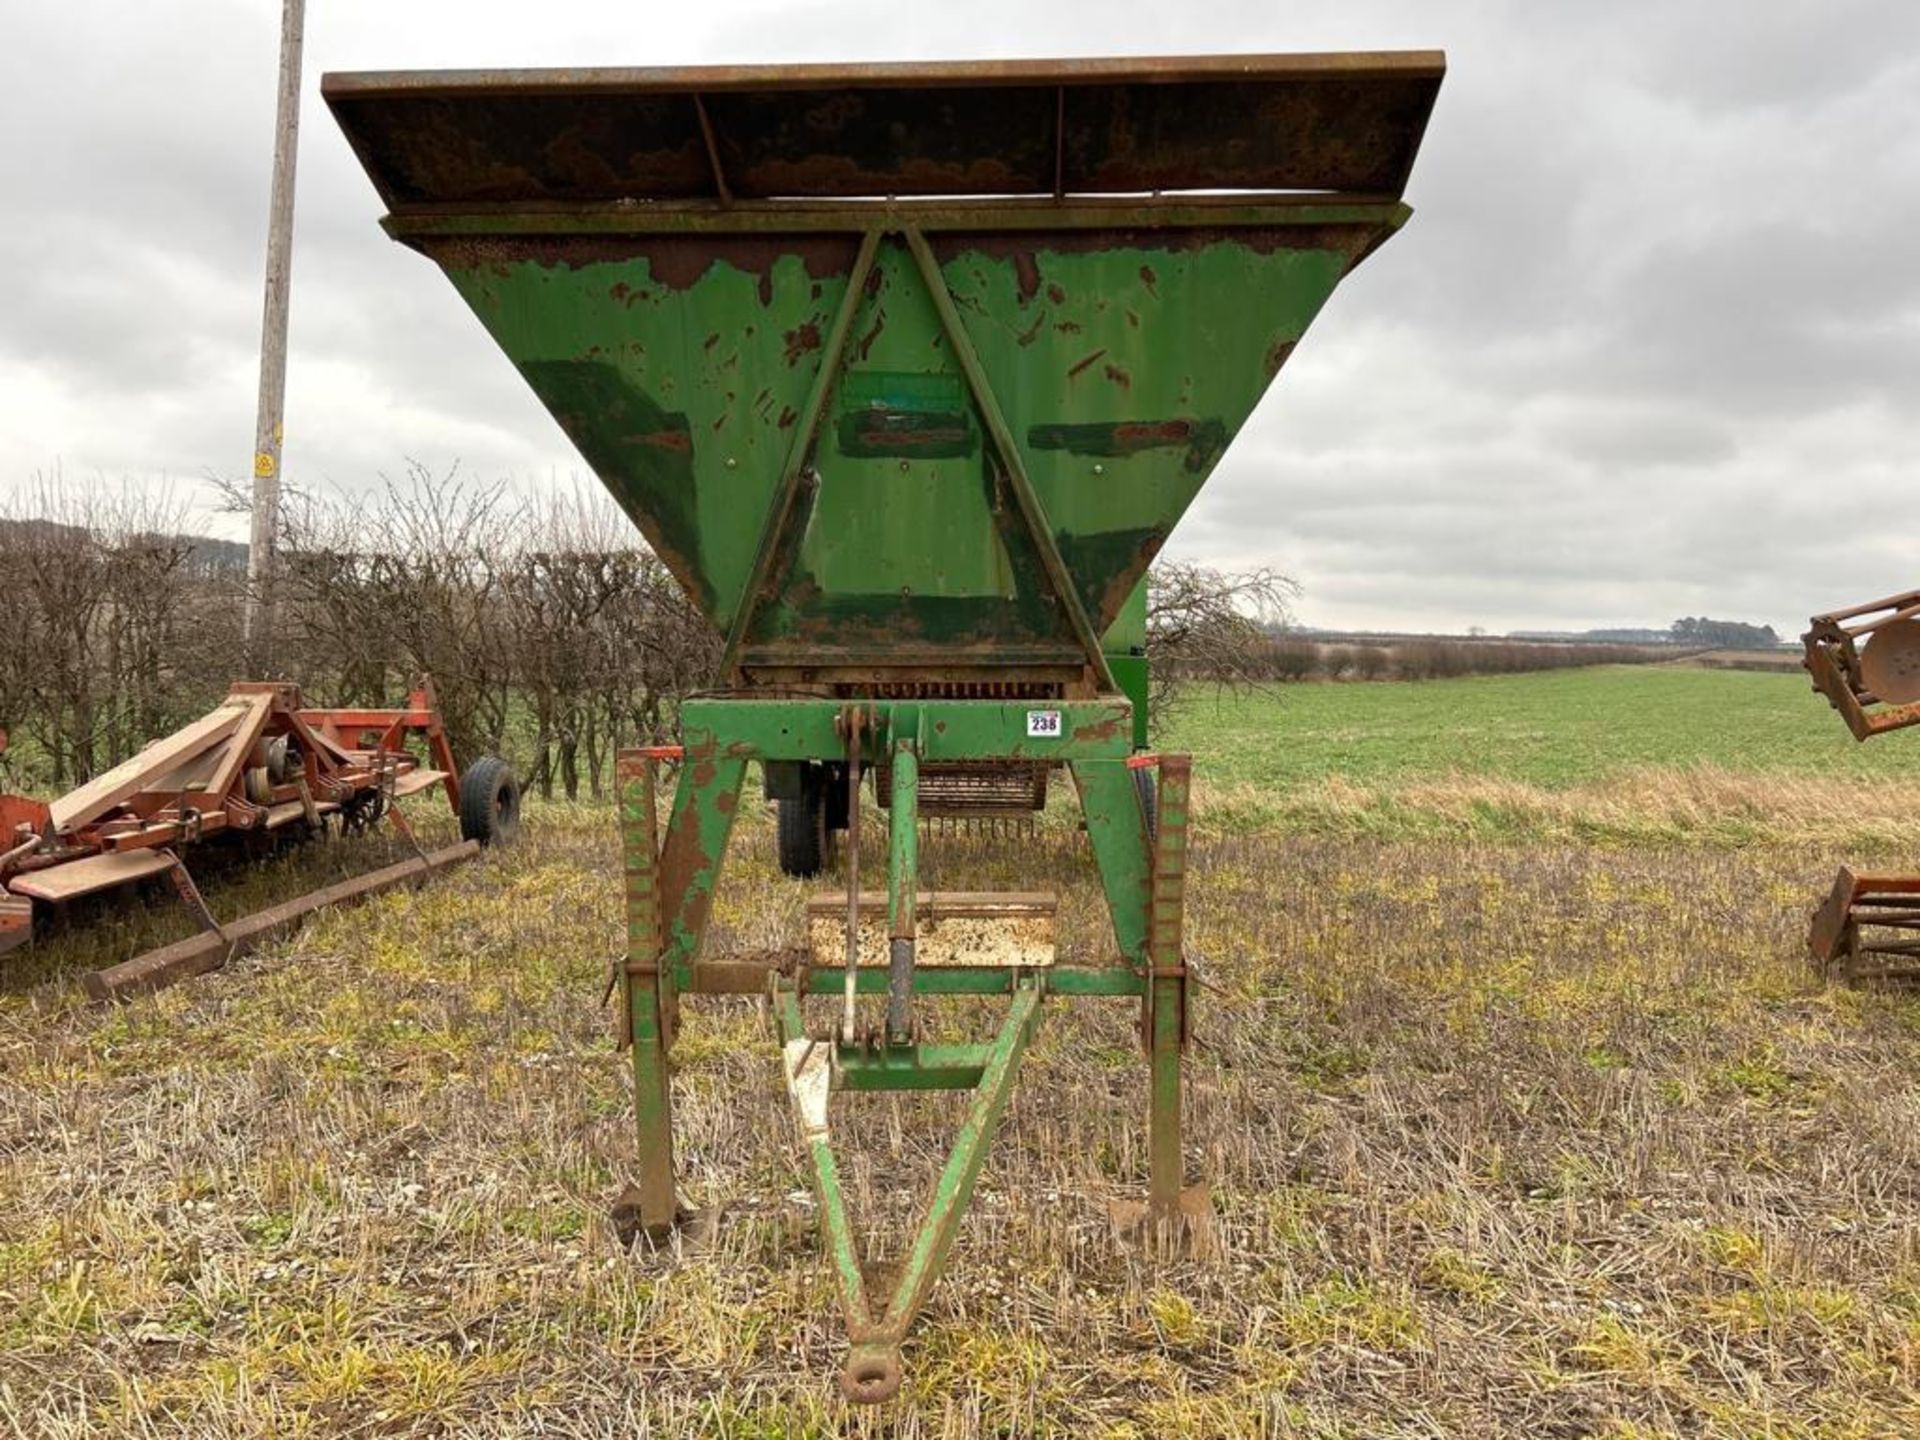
[246, 0, 307, 672]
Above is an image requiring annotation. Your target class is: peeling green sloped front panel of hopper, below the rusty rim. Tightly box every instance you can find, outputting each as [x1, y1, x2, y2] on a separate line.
[420, 204, 1404, 668]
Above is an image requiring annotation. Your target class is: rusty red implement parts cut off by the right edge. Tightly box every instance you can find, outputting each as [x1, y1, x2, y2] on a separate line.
[1801, 589, 1920, 983]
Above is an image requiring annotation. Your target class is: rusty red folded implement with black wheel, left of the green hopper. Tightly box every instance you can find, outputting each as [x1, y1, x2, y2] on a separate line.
[0, 680, 520, 1000]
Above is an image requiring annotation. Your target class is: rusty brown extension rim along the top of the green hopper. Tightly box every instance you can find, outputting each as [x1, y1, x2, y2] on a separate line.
[321, 52, 1446, 209]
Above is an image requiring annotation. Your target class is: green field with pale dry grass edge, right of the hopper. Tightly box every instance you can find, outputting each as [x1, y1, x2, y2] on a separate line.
[1158, 666, 1920, 858]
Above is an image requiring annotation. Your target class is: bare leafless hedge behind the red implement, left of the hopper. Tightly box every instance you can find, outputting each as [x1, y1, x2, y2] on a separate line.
[0, 468, 718, 795]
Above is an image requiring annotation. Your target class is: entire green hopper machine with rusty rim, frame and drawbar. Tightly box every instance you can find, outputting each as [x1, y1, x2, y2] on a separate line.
[323, 52, 1444, 1400]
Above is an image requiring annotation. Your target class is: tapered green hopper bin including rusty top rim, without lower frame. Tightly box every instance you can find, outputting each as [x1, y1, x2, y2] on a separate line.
[323, 52, 1442, 693]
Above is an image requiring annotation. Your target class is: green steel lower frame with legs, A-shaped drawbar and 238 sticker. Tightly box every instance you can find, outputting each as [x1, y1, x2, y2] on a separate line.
[618, 699, 1190, 1402]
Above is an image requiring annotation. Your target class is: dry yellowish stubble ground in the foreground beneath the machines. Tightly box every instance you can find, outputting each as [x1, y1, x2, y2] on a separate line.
[0, 781, 1920, 1440]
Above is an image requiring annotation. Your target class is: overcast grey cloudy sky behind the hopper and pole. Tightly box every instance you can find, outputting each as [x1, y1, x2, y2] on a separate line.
[0, 0, 1920, 634]
